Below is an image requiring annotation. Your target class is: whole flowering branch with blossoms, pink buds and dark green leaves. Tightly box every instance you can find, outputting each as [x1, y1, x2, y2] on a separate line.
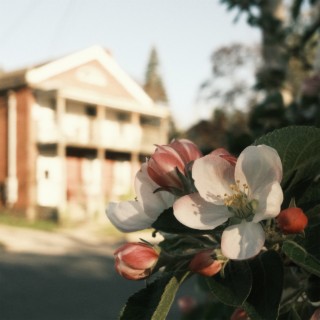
[107, 123, 320, 320]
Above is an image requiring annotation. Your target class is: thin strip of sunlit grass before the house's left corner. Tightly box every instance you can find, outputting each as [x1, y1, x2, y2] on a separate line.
[0, 213, 58, 231]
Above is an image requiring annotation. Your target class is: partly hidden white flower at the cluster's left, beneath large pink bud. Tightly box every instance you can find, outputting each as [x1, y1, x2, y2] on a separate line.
[107, 163, 175, 232]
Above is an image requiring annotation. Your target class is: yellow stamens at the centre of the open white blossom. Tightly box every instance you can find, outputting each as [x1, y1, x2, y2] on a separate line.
[223, 180, 258, 221]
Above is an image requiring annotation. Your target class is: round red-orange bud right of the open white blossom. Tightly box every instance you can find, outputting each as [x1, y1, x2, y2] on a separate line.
[277, 207, 308, 234]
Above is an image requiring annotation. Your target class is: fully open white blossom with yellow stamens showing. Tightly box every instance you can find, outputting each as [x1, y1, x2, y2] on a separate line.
[173, 145, 283, 259]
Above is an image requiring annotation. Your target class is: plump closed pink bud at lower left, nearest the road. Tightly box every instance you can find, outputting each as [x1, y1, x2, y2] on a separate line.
[114, 242, 159, 280]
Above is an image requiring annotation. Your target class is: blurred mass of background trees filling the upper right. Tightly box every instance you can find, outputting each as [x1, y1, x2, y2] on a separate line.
[191, 0, 320, 154]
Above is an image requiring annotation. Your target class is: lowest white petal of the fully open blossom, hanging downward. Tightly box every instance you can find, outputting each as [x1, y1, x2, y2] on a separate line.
[221, 220, 265, 260]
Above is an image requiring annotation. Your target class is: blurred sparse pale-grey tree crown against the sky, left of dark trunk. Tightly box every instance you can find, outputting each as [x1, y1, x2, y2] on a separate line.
[198, 43, 261, 111]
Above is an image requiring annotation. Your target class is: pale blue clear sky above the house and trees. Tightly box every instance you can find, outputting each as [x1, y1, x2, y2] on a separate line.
[0, 0, 260, 128]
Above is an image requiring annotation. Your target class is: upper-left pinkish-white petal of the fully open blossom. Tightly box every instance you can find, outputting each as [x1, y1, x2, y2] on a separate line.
[192, 154, 234, 204]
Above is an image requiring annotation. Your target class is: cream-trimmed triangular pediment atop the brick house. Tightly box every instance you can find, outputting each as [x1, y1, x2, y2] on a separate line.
[26, 47, 153, 105]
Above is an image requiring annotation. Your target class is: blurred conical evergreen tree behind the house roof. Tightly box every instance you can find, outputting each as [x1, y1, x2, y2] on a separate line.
[143, 47, 168, 103]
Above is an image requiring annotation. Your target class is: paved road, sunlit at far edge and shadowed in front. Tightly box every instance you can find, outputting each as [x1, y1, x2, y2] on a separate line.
[0, 225, 194, 320]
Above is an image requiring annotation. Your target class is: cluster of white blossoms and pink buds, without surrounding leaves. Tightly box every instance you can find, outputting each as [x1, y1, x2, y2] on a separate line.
[108, 139, 308, 292]
